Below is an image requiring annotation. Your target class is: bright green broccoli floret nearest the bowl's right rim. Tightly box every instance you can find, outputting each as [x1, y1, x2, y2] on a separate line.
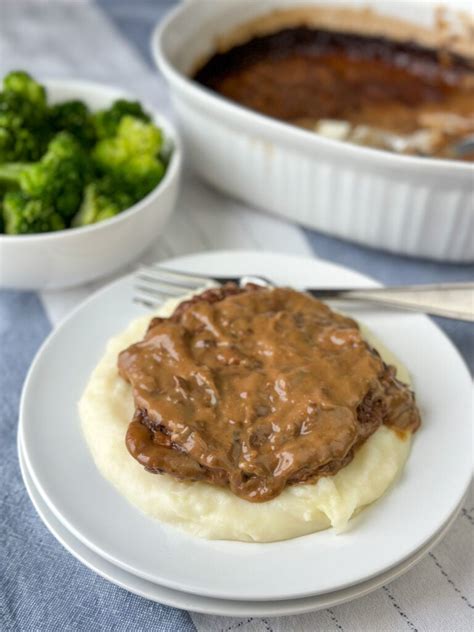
[92, 116, 165, 202]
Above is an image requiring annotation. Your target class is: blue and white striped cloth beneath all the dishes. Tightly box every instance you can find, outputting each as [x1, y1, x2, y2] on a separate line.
[0, 0, 474, 632]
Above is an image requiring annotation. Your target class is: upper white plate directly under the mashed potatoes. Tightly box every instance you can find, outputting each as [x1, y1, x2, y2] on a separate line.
[19, 251, 472, 601]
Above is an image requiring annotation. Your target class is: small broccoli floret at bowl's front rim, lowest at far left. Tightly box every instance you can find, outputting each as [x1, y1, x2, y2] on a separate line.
[3, 191, 66, 235]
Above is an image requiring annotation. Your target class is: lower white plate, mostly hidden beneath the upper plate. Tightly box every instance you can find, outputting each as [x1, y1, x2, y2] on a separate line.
[18, 432, 462, 617]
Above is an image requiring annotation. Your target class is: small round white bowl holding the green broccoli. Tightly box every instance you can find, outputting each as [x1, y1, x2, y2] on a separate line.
[0, 81, 182, 289]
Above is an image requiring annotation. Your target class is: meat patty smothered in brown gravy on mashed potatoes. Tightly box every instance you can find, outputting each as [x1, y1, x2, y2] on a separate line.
[118, 286, 420, 502]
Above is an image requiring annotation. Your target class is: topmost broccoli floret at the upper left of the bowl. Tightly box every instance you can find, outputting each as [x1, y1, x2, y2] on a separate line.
[0, 72, 51, 162]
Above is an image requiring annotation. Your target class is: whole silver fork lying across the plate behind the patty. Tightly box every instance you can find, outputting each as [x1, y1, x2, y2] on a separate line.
[133, 265, 474, 322]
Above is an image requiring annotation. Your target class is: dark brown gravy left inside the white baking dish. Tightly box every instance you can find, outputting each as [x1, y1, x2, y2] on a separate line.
[194, 26, 474, 159]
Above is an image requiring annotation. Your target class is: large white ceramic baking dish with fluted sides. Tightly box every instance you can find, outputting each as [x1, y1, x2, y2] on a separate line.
[152, 0, 474, 261]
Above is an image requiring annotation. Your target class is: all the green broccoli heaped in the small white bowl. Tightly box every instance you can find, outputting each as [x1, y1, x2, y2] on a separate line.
[0, 71, 167, 235]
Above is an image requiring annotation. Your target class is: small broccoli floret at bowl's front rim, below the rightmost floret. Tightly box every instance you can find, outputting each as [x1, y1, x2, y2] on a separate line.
[72, 176, 134, 227]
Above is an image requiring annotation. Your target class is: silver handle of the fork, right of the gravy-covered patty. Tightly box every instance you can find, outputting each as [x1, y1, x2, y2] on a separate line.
[305, 283, 474, 322]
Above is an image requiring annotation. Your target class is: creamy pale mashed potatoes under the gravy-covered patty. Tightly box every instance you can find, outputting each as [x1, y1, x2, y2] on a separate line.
[79, 301, 410, 542]
